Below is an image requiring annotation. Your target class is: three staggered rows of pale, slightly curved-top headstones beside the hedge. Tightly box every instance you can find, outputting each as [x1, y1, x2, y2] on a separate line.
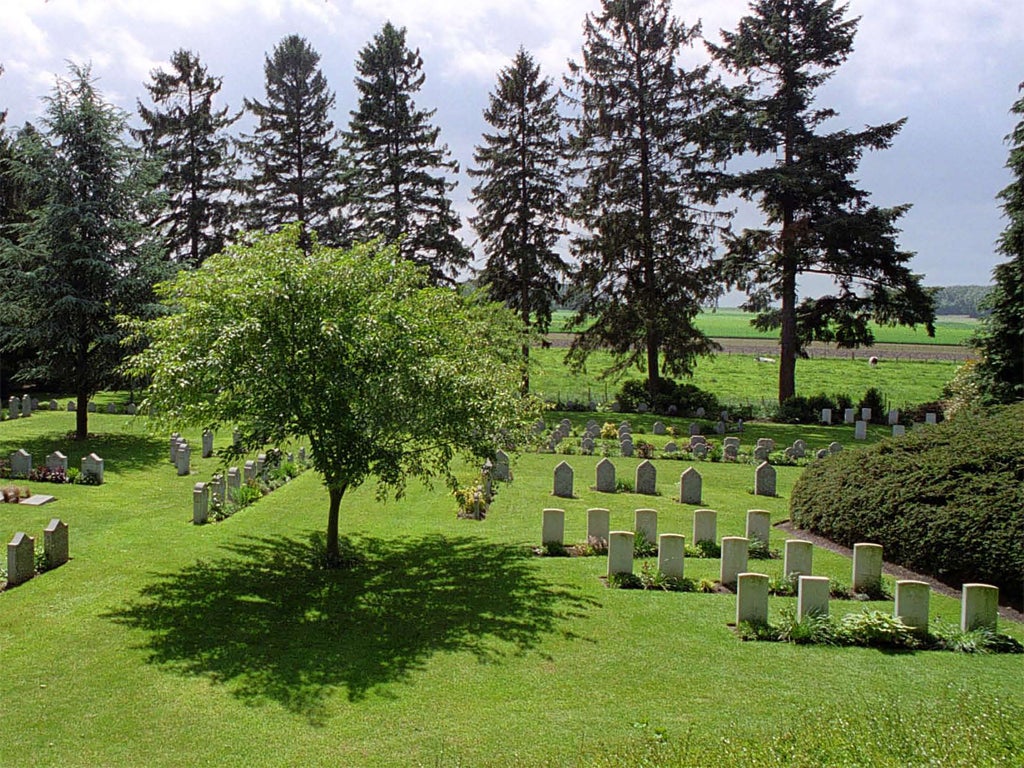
[542, 509, 999, 632]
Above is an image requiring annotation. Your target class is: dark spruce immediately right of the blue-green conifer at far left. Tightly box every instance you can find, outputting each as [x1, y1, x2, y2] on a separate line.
[132, 49, 239, 267]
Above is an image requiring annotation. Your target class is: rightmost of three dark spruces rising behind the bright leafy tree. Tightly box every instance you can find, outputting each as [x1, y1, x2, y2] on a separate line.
[345, 22, 470, 283]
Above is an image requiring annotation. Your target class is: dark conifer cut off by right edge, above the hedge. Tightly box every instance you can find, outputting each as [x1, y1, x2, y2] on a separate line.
[975, 83, 1024, 402]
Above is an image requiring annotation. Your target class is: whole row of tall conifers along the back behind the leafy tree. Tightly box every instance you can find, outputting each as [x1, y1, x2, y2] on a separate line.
[0, 0, 1015, 423]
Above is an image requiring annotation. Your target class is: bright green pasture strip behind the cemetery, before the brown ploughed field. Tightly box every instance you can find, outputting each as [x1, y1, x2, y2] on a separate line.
[530, 347, 959, 411]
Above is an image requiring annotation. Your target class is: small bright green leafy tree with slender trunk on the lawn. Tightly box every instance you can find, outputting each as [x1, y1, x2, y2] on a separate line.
[129, 224, 532, 564]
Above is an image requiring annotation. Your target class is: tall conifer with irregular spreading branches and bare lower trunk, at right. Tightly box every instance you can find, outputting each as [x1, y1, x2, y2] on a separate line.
[709, 0, 934, 403]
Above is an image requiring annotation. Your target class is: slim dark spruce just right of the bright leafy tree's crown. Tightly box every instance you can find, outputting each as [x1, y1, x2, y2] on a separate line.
[469, 48, 566, 391]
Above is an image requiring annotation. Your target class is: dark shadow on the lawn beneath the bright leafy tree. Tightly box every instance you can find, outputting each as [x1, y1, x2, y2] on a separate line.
[108, 536, 594, 723]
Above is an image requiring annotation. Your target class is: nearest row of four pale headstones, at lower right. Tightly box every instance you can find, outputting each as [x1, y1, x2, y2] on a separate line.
[737, 577, 999, 632]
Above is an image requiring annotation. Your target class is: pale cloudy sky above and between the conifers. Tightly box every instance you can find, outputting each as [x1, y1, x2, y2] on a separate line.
[0, 0, 1024, 286]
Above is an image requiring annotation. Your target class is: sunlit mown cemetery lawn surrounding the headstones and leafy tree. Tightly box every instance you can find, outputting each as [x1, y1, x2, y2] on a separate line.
[0, 413, 1024, 768]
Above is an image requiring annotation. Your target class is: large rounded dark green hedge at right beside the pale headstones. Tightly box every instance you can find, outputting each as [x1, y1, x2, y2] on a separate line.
[790, 403, 1024, 607]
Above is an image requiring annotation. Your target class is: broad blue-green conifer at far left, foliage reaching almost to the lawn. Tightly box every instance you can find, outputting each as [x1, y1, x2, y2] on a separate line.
[0, 65, 166, 439]
